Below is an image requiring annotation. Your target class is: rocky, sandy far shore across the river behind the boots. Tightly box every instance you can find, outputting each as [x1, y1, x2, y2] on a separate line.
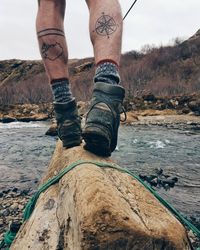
[0, 96, 200, 139]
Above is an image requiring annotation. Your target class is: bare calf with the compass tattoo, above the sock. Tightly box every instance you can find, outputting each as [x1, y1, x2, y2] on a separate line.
[86, 0, 123, 65]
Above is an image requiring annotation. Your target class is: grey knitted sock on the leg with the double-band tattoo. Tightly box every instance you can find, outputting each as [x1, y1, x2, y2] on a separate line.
[51, 78, 74, 103]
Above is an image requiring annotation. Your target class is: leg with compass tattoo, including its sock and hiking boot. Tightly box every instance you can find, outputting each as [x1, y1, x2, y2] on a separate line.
[83, 0, 125, 156]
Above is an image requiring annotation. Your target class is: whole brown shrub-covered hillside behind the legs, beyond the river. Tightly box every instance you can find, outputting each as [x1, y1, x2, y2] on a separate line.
[0, 30, 200, 104]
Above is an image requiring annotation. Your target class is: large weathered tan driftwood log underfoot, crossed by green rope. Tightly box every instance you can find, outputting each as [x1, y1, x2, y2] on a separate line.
[10, 141, 191, 250]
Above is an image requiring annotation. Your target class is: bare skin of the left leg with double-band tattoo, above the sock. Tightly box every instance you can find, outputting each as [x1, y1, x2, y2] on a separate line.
[36, 0, 69, 82]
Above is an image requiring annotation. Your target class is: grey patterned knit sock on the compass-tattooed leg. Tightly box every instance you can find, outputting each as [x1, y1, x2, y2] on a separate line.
[94, 60, 121, 84]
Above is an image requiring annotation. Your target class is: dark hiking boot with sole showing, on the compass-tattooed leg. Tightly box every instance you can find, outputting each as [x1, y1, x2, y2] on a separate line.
[82, 82, 125, 156]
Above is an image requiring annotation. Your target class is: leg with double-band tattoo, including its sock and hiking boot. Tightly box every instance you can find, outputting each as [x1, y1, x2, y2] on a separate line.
[36, 0, 81, 147]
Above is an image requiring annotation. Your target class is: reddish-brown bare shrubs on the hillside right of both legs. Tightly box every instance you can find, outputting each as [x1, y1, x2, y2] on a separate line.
[121, 39, 200, 98]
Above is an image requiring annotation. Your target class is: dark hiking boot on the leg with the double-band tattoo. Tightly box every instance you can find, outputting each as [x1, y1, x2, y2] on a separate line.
[54, 99, 81, 148]
